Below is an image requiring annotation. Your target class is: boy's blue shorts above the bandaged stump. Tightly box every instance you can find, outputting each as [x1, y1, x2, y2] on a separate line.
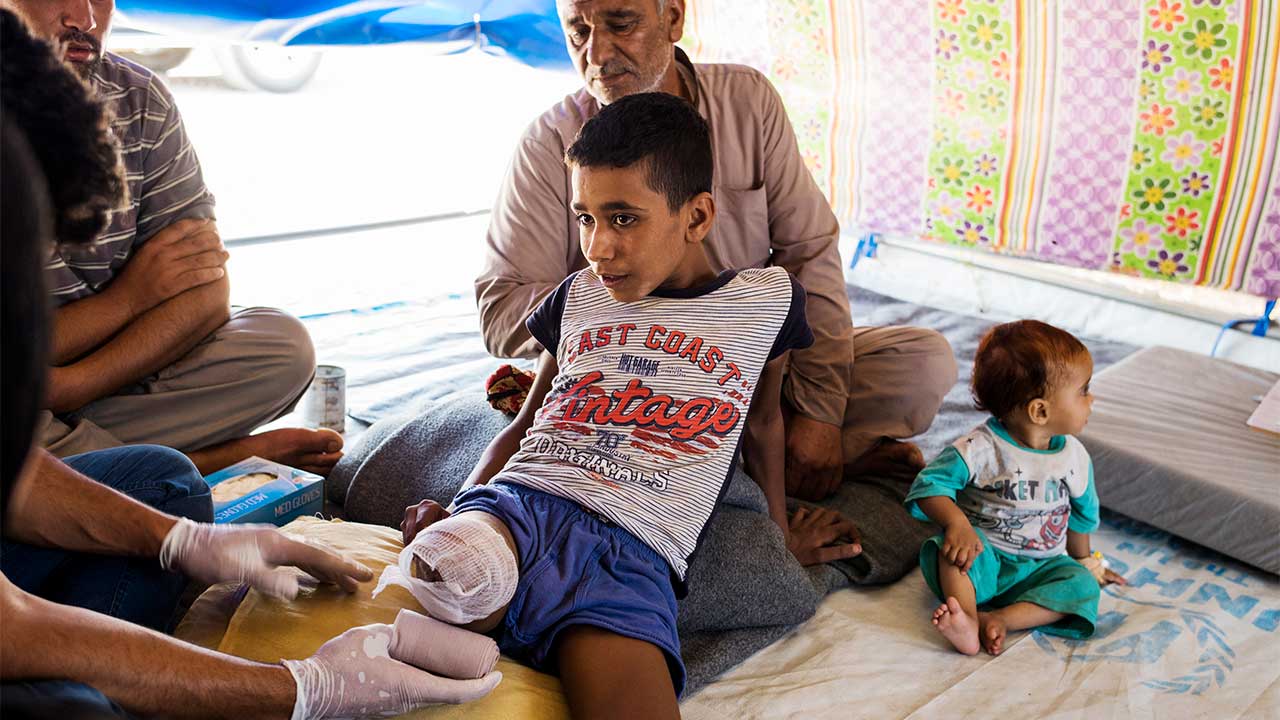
[453, 482, 685, 697]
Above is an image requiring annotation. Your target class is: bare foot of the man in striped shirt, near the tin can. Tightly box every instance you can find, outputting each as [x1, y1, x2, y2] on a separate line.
[187, 428, 342, 475]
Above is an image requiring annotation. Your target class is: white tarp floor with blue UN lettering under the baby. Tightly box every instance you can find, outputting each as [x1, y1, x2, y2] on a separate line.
[681, 514, 1280, 720]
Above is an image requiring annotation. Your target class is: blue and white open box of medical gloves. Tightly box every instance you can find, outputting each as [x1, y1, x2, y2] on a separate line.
[205, 457, 324, 525]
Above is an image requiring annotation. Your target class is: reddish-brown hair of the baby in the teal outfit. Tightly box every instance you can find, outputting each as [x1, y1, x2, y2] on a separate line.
[973, 320, 1089, 419]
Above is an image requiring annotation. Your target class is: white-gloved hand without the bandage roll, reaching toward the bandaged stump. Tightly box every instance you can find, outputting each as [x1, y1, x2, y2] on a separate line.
[160, 518, 374, 600]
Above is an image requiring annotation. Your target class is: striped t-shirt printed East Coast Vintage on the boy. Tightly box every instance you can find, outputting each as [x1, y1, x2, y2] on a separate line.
[493, 268, 813, 580]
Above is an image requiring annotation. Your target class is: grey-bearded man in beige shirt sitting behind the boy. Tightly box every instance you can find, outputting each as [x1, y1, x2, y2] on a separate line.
[476, 0, 956, 500]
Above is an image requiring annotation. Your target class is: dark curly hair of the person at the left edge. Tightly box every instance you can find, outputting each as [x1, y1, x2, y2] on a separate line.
[0, 9, 128, 243]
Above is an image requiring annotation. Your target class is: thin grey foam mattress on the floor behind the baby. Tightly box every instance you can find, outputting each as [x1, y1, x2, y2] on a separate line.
[1080, 347, 1280, 573]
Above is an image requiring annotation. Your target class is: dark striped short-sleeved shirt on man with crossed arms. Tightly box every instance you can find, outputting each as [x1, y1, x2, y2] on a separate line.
[45, 53, 214, 306]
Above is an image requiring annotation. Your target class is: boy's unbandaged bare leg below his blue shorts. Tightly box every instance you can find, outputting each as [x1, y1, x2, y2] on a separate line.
[557, 625, 680, 720]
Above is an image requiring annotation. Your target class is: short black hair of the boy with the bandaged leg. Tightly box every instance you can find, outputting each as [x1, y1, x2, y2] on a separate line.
[564, 92, 714, 213]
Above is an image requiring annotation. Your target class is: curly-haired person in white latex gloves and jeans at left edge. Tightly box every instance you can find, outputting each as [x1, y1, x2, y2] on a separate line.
[0, 10, 500, 720]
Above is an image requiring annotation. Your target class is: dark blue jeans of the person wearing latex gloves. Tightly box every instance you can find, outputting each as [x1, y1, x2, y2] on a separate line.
[0, 445, 214, 717]
